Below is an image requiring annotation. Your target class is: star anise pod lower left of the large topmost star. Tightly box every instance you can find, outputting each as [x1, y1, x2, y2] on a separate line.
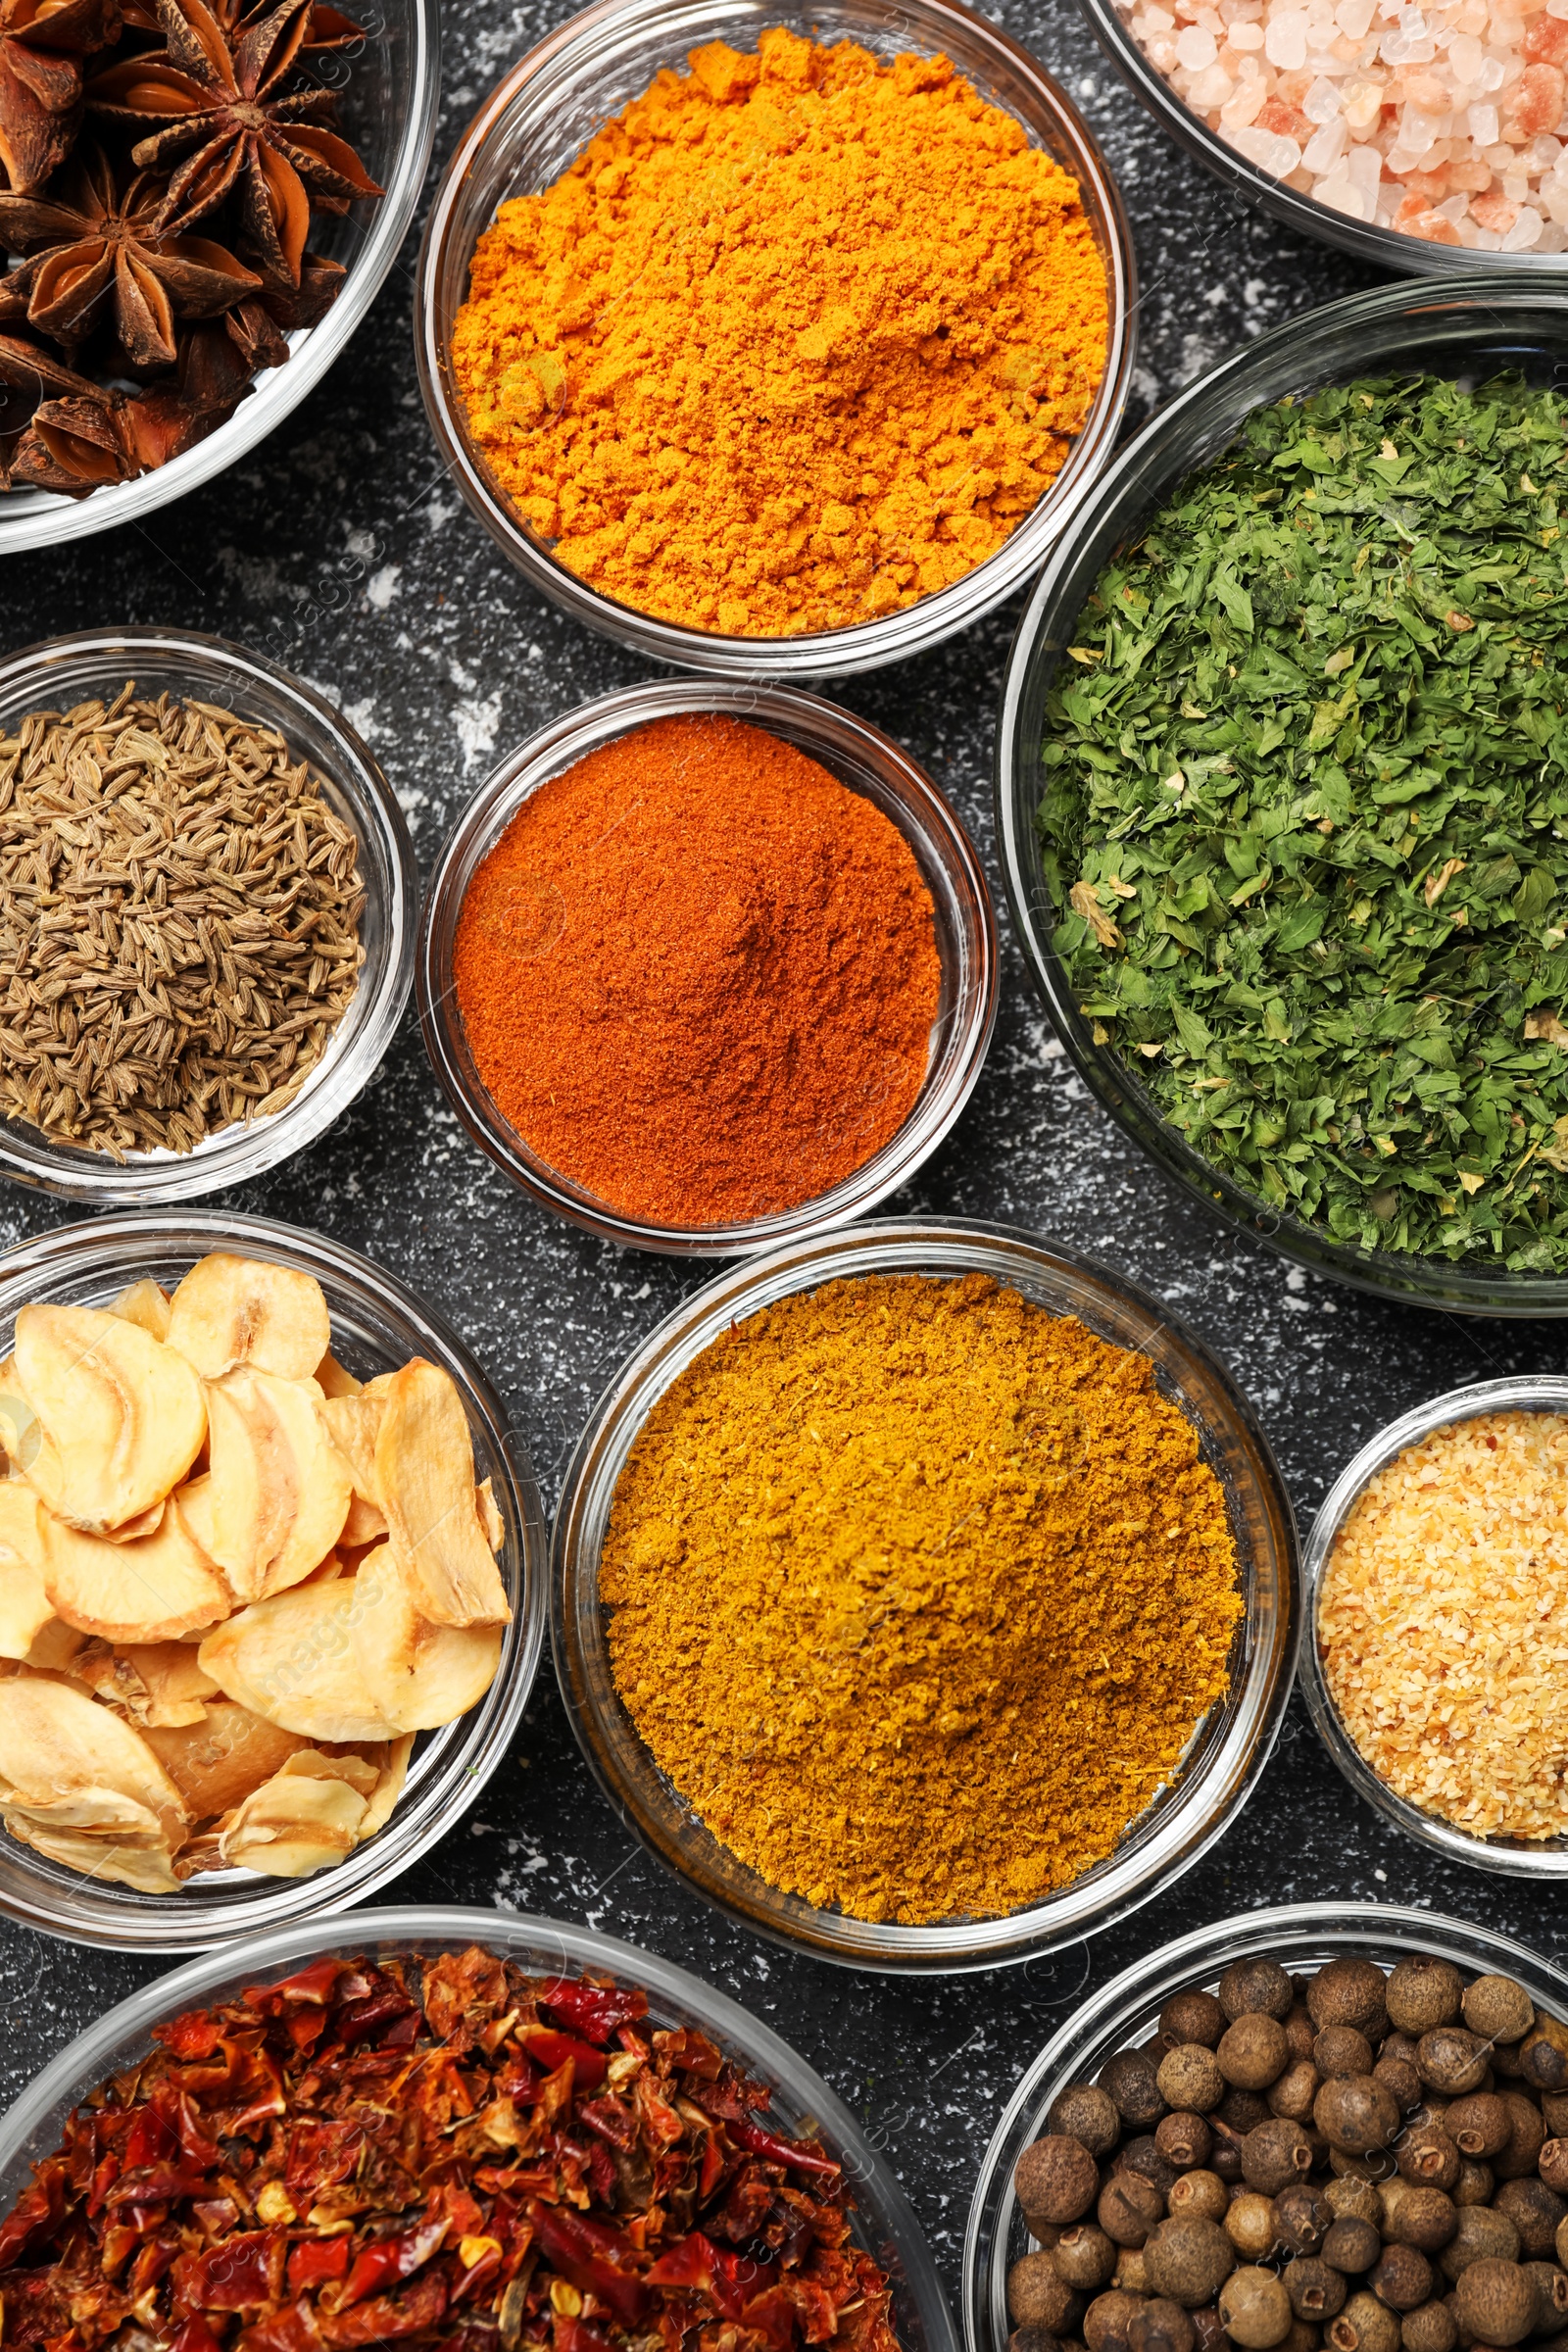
[0, 148, 261, 369]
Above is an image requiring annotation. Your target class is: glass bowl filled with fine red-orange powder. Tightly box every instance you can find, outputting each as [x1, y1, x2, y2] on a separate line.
[416, 680, 997, 1256]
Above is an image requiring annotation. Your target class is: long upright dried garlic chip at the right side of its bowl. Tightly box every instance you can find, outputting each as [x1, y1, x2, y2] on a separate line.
[376, 1354, 513, 1625]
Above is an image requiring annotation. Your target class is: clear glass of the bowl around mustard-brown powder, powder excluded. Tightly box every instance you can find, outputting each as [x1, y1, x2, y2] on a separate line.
[550, 1216, 1300, 1974]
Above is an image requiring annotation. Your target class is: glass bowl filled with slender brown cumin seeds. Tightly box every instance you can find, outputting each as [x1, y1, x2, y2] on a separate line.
[0, 628, 416, 1206]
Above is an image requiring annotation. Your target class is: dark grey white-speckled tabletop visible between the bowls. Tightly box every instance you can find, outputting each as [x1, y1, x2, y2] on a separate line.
[0, 0, 1568, 2324]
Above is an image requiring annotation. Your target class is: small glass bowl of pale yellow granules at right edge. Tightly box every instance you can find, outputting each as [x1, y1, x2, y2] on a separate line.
[1300, 1374, 1568, 1882]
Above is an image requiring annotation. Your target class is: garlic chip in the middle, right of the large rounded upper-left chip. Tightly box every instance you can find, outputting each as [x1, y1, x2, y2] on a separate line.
[197, 1371, 353, 1601]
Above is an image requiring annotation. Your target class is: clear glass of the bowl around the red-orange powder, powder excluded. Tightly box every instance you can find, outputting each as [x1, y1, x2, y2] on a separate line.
[414, 680, 997, 1258]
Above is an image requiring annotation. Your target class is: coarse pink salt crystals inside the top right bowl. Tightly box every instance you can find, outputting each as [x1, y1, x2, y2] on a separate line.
[1116, 0, 1568, 254]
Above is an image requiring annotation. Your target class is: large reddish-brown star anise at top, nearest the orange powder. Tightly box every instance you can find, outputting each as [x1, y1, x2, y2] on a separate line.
[87, 0, 385, 287]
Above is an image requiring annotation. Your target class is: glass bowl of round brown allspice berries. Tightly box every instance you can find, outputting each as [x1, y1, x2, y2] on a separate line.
[964, 1903, 1568, 2352]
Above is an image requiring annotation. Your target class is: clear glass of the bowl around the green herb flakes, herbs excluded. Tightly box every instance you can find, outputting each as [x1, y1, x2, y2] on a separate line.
[997, 272, 1568, 1315]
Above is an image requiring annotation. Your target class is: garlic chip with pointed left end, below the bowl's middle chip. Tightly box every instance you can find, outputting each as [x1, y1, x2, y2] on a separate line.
[197, 1576, 402, 1742]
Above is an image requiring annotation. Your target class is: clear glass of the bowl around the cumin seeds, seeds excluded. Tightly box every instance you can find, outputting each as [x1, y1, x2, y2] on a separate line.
[0, 625, 418, 1206]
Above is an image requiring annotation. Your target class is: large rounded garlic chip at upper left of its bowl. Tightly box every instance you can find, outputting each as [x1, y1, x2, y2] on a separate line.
[14, 1305, 207, 1536]
